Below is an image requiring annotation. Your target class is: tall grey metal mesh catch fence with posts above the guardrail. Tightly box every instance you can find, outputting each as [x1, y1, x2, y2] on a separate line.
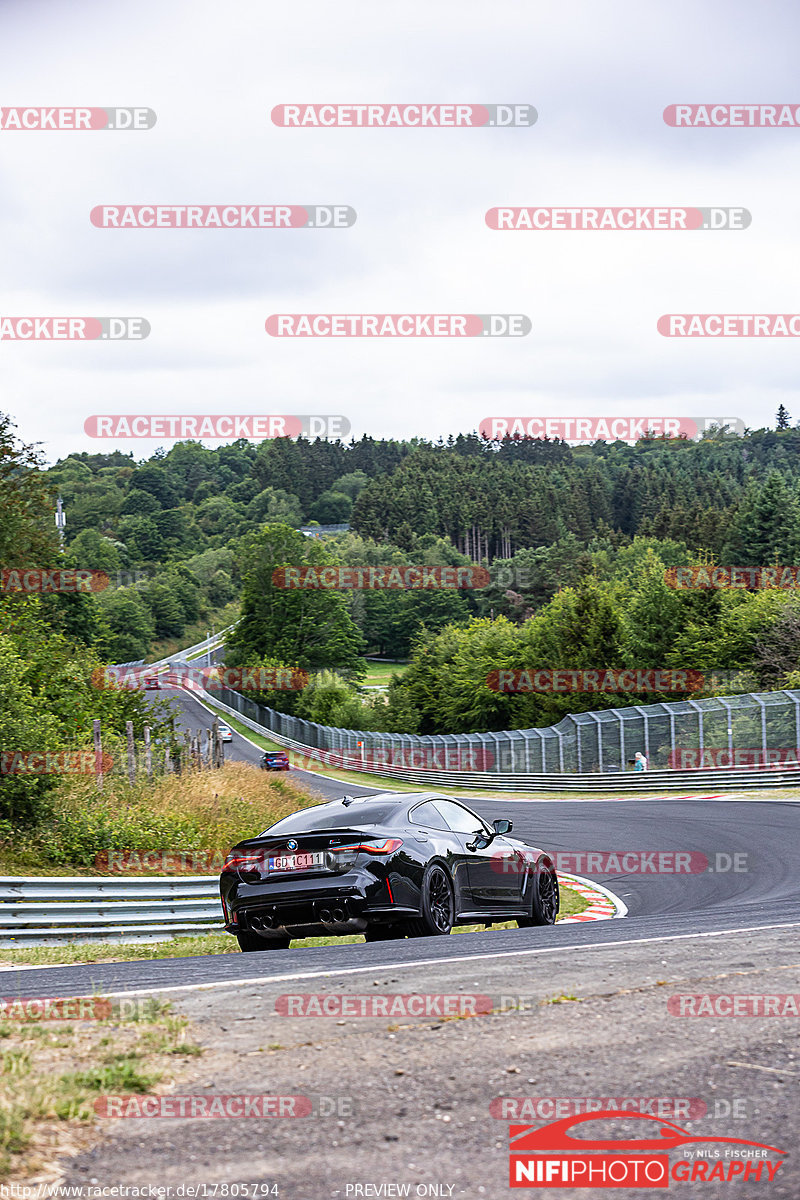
[209, 688, 800, 786]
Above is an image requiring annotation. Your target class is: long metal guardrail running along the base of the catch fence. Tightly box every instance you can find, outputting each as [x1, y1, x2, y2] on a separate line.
[188, 689, 800, 792]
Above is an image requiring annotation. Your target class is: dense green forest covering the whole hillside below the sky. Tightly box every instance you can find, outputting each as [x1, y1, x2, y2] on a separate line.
[0, 413, 800, 782]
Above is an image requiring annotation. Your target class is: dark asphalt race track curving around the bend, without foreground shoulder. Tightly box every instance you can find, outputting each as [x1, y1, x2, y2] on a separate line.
[0, 692, 800, 995]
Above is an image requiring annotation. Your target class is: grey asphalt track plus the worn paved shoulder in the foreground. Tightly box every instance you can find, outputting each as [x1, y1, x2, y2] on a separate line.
[6, 694, 800, 1200]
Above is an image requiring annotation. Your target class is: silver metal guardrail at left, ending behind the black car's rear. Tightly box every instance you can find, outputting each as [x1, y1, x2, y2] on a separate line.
[0, 875, 223, 947]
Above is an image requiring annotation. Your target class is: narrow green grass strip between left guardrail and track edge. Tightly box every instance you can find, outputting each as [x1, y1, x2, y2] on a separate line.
[0, 886, 589, 967]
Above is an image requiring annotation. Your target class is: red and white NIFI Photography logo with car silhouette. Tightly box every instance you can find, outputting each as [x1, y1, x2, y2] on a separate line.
[509, 1109, 786, 1195]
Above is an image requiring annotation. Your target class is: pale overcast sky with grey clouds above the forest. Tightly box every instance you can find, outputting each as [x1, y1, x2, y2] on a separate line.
[0, 0, 800, 461]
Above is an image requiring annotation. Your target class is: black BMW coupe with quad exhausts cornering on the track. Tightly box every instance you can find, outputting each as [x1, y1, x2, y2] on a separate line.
[219, 792, 559, 950]
